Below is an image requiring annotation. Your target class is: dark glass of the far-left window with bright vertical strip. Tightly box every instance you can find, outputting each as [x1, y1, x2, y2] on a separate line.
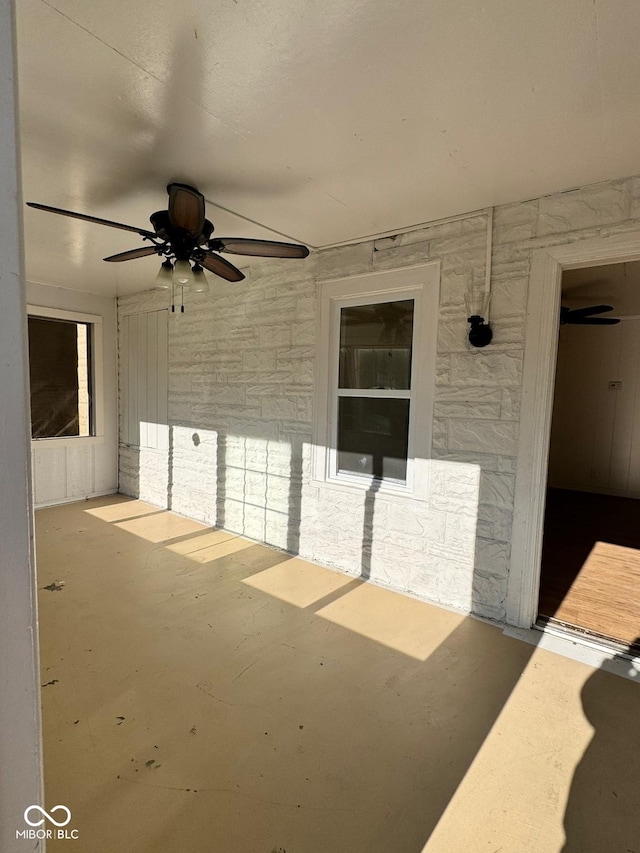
[29, 317, 91, 438]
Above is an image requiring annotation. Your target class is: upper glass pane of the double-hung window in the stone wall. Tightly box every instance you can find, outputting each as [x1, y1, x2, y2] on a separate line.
[339, 299, 414, 390]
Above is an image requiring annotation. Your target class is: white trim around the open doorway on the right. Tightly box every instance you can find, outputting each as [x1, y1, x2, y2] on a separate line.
[505, 231, 640, 628]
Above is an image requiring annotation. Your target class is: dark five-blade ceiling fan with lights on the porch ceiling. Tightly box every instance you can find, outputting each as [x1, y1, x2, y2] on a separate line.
[27, 183, 309, 286]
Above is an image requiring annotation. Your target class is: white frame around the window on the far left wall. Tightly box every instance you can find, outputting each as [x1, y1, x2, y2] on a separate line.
[27, 305, 104, 447]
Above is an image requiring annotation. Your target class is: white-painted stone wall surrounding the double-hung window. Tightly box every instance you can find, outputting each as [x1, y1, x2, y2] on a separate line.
[119, 178, 640, 620]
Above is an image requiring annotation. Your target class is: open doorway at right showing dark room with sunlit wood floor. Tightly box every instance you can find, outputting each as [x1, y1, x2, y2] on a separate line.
[537, 261, 640, 650]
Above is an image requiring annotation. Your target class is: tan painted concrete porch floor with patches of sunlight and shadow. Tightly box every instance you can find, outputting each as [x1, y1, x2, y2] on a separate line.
[36, 496, 640, 853]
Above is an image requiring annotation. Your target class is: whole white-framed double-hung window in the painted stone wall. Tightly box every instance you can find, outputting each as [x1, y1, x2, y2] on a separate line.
[314, 264, 439, 497]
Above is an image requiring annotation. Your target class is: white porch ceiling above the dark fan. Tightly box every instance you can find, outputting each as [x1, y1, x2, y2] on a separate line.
[17, 0, 640, 294]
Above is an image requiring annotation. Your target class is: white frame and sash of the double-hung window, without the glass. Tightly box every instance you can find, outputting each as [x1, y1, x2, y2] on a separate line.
[312, 261, 440, 500]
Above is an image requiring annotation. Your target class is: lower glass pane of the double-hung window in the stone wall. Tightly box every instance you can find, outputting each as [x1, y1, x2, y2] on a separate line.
[338, 397, 409, 482]
